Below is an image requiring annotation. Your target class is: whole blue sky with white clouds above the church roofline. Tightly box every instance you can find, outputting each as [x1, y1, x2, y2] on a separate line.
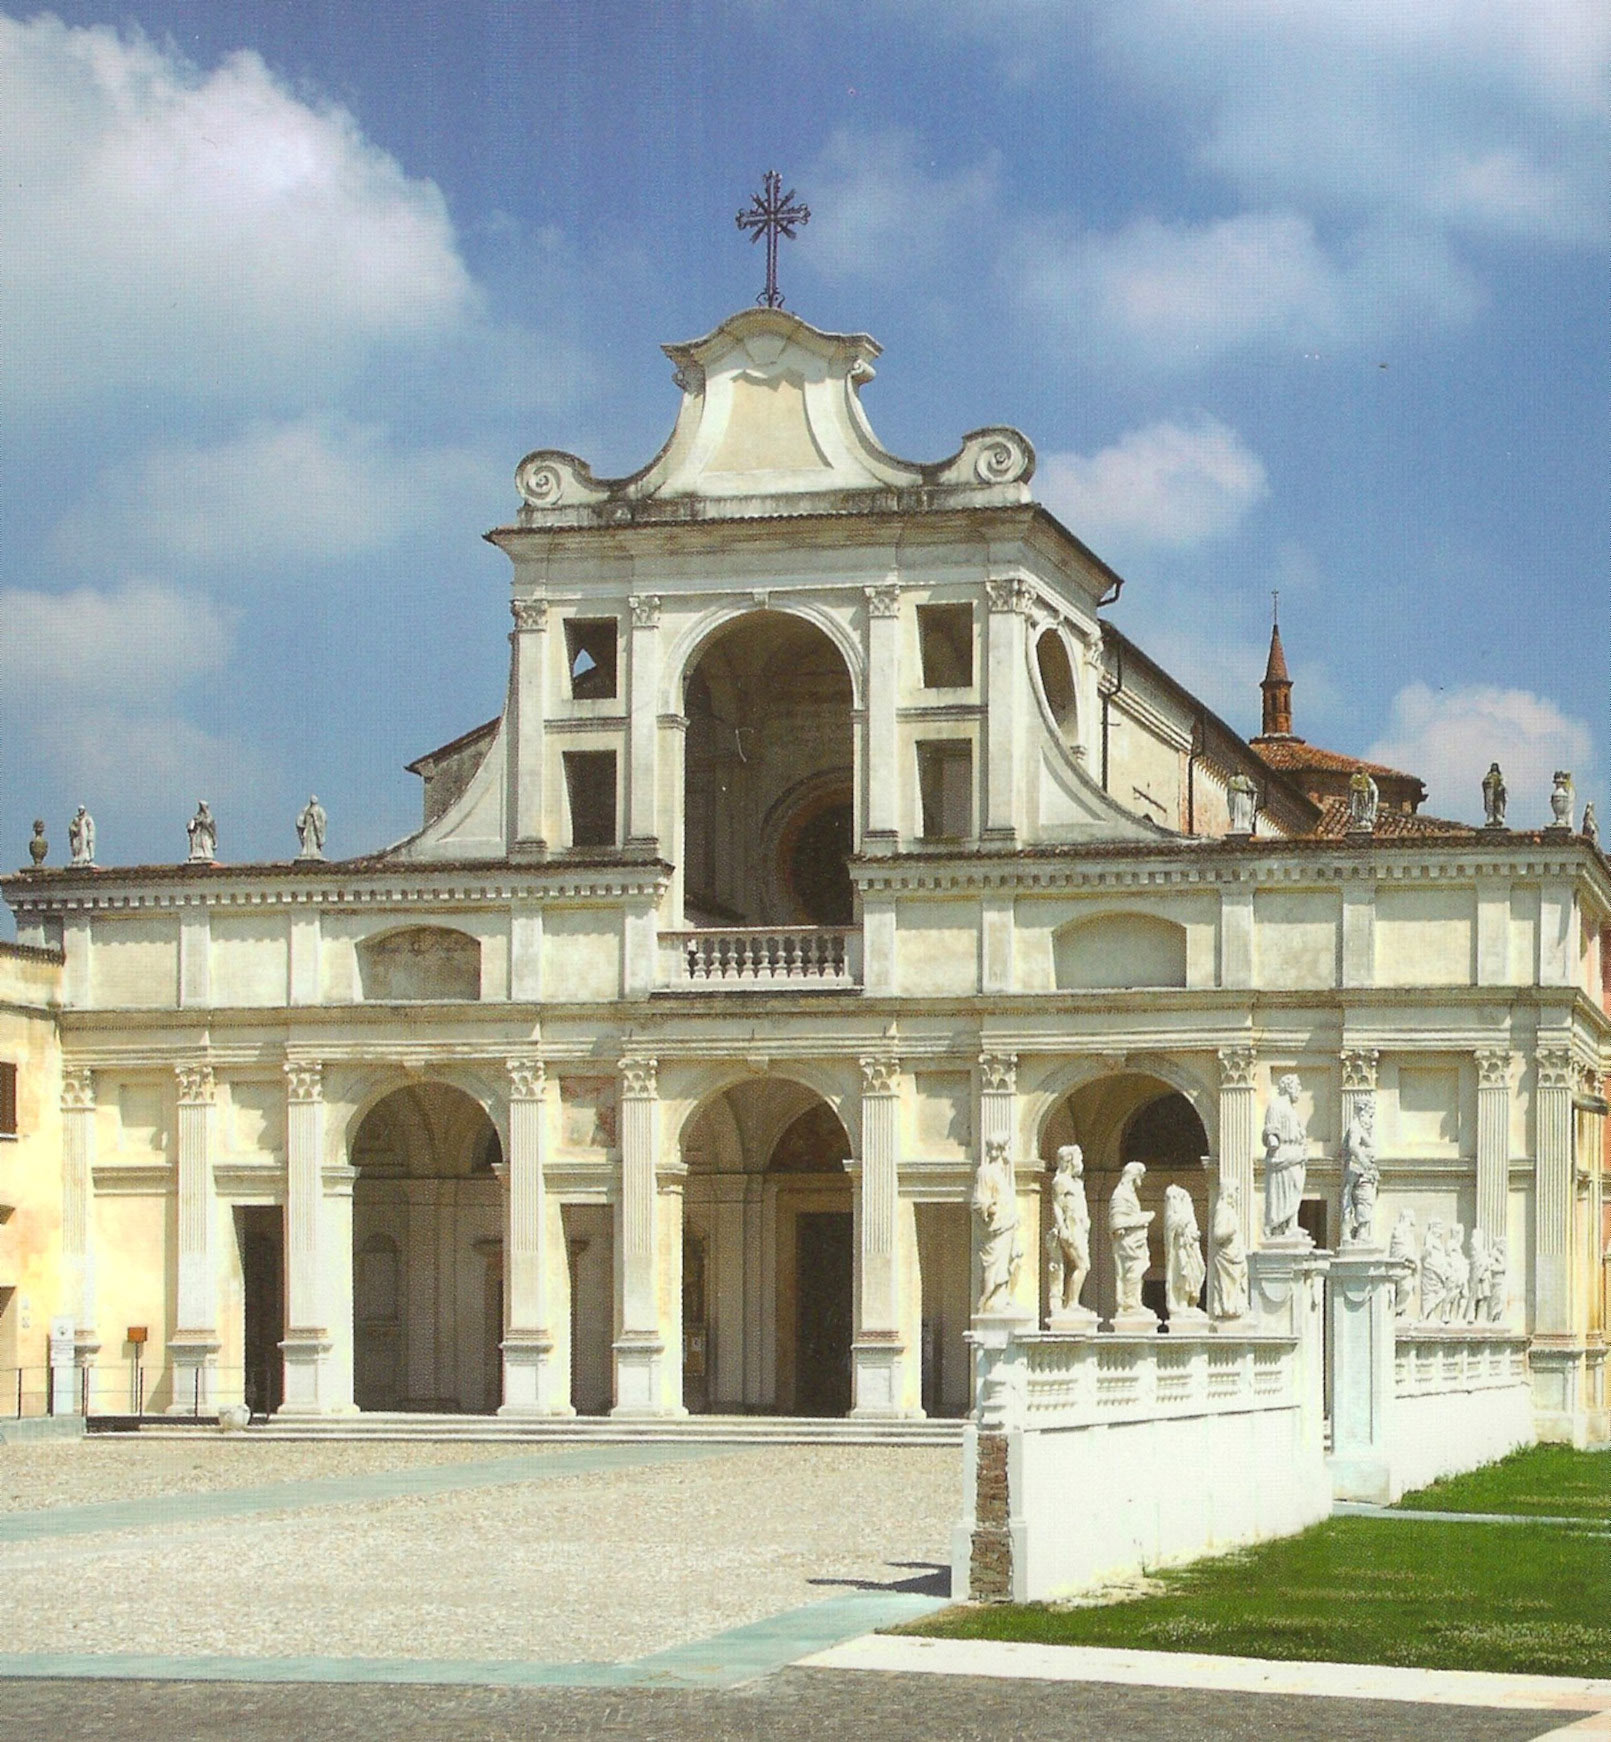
[0, 0, 1611, 864]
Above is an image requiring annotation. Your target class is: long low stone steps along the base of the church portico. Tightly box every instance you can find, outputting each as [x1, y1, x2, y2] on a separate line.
[128, 1411, 963, 1446]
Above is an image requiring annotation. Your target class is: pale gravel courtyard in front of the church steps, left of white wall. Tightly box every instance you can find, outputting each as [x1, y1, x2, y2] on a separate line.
[0, 1437, 958, 1662]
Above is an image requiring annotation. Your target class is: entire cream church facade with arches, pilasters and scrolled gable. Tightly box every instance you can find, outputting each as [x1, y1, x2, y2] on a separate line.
[0, 308, 1611, 1442]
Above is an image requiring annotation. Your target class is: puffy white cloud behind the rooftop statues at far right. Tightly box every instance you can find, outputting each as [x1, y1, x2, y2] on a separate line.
[1365, 683, 1597, 827]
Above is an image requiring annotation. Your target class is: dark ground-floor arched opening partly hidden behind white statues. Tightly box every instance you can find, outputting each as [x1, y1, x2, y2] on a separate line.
[1040, 1071, 1212, 1319]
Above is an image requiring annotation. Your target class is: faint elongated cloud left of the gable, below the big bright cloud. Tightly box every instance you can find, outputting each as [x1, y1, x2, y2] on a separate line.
[56, 413, 505, 571]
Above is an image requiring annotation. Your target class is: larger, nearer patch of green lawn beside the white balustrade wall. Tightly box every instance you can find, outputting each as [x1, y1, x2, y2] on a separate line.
[900, 1519, 1611, 1676]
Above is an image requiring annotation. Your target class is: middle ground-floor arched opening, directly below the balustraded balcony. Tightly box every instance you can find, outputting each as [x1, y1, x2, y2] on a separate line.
[683, 1077, 855, 1416]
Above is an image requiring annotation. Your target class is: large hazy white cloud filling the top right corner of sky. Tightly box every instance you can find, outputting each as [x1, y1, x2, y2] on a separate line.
[1095, 0, 1611, 242]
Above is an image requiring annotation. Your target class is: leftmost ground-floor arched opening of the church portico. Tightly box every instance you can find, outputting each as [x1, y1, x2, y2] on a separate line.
[352, 1082, 503, 1415]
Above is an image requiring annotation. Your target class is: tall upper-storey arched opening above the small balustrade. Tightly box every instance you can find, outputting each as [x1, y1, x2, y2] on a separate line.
[683, 611, 855, 927]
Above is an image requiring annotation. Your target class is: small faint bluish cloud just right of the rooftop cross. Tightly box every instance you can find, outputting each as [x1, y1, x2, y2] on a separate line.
[801, 127, 1000, 282]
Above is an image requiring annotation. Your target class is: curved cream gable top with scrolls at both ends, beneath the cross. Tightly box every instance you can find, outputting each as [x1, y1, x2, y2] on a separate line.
[516, 308, 1035, 526]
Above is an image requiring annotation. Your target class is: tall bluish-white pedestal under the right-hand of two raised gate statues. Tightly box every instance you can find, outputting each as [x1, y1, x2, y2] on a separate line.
[1329, 1247, 1399, 1505]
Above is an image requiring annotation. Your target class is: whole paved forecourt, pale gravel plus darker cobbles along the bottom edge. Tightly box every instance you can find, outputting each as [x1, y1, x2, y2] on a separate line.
[0, 1437, 1588, 1742]
